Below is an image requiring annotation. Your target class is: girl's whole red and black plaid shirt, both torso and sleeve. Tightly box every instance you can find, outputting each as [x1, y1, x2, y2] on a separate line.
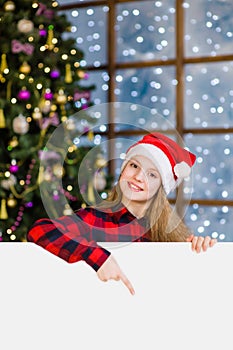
[27, 205, 149, 271]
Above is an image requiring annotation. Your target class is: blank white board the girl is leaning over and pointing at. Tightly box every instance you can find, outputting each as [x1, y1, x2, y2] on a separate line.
[0, 243, 233, 350]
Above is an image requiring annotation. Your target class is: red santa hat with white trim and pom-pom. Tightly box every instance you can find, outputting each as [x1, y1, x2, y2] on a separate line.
[122, 132, 196, 194]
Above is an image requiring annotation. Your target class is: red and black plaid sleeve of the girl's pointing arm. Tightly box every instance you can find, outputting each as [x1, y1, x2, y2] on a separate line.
[27, 216, 110, 271]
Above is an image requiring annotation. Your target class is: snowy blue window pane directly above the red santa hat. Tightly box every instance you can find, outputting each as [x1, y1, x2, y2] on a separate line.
[115, 66, 177, 130]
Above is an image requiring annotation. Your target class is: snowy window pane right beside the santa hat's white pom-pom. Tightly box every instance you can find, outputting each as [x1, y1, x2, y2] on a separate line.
[185, 133, 233, 200]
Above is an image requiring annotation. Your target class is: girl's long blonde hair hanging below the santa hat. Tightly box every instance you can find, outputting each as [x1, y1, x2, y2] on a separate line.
[101, 182, 191, 242]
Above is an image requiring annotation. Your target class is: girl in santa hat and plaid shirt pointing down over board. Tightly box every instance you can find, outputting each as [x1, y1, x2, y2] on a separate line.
[28, 133, 216, 294]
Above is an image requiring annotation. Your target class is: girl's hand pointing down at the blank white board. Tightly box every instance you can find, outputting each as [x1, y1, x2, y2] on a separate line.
[97, 255, 135, 295]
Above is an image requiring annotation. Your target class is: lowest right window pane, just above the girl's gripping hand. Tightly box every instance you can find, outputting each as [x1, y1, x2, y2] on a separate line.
[185, 204, 233, 242]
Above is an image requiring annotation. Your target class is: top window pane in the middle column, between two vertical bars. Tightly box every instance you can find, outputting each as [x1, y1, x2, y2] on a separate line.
[115, 0, 175, 62]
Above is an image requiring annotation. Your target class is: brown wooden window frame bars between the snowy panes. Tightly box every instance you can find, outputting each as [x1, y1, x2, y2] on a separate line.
[59, 0, 233, 215]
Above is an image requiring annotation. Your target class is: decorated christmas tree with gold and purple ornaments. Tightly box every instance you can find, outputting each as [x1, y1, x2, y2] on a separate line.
[0, 0, 105, 241]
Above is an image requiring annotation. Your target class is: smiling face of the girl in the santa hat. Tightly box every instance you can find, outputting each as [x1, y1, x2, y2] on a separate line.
[119, 156, 161, 216]
